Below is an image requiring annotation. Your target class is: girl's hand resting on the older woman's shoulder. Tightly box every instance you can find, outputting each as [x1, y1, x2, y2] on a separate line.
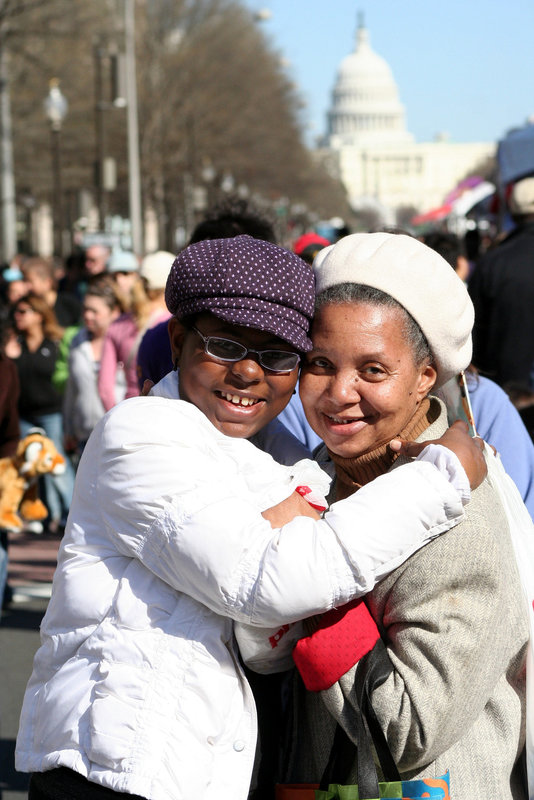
[389, 420, 488, 489]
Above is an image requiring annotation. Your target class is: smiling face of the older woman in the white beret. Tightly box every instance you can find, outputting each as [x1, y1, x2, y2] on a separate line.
[300, 302, 436, 457]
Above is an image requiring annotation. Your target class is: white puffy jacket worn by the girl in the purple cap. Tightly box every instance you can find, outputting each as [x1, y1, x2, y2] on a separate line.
[16, 384, 465, 800]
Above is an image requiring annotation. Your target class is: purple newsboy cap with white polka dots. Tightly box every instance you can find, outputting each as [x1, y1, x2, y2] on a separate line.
[165, 235, 315, 353]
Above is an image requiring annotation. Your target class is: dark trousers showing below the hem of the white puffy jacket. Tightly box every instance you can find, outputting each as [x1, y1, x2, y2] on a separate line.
[28, 767, 146, 800]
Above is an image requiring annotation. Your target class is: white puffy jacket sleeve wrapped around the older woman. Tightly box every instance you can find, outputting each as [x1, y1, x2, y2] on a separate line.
[91, 398, 463, 626]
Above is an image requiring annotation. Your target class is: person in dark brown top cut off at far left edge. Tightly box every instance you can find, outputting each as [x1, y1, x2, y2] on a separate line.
[0, 316, 20, 607]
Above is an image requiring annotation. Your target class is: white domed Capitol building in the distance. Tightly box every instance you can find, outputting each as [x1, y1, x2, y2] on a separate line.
[323, 16, 496, 225]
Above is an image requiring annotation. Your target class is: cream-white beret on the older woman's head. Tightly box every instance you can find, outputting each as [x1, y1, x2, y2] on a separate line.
[313, 233, 475, 387]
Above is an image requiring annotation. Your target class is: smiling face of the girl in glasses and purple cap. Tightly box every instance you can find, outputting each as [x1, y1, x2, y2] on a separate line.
[169, 314, 298, 438]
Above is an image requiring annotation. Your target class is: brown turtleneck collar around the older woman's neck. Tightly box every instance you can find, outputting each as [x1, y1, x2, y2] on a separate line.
[328, 397, 434, 500]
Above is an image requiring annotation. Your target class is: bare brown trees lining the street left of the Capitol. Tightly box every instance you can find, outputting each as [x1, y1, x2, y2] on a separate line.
[4, 0, 346, 252]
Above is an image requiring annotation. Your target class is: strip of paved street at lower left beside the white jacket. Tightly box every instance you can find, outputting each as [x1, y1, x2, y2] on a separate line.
[0, 534, 60, 800]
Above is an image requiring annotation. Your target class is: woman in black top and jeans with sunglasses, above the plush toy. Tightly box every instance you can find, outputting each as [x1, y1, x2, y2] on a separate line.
[6, 292, 74, 533]
